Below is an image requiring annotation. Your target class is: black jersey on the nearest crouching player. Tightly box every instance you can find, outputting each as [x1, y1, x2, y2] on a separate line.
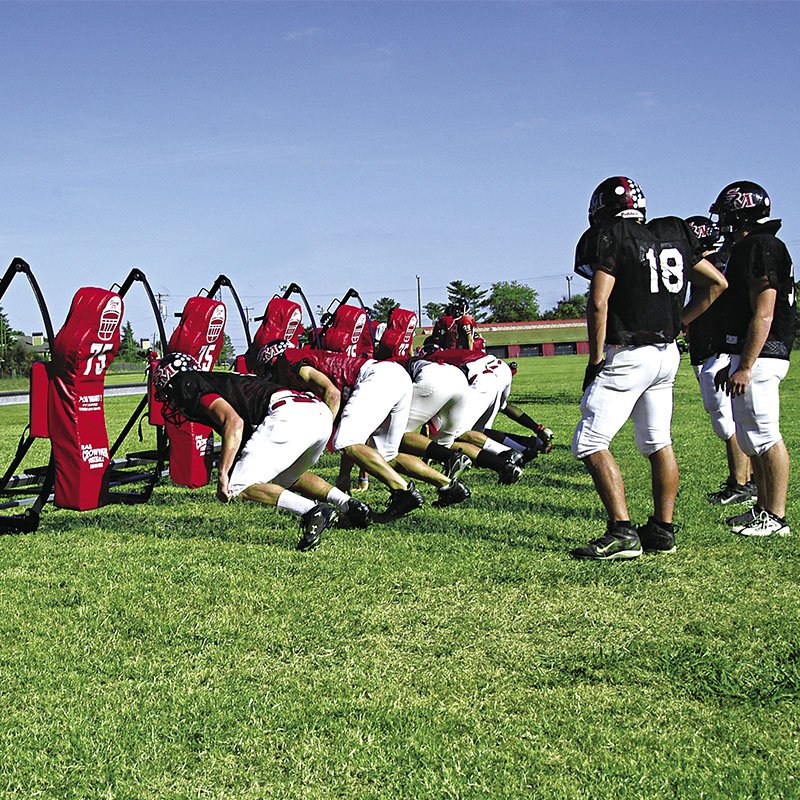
[170, 372, 283, 444]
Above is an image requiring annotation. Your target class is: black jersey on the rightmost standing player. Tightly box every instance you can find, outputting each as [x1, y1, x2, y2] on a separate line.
[717, 220, 797, 359]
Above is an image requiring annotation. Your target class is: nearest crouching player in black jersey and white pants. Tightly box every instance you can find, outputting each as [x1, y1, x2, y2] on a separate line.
[153, 353, 371, 550]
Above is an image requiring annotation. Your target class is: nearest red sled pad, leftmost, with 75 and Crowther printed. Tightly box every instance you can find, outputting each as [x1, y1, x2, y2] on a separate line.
[47, 287, 124, 511]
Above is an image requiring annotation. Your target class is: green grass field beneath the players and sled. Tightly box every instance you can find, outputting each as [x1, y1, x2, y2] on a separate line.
[0, 357, 800, 800]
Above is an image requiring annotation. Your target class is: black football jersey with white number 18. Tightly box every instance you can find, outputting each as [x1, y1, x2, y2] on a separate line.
[575, 217, 703, 345]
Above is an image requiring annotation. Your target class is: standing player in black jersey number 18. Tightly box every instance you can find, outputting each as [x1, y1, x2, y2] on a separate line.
[572, 176, 726, 560]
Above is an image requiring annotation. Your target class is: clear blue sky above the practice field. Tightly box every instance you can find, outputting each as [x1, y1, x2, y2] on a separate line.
[0, 2, 800, 344]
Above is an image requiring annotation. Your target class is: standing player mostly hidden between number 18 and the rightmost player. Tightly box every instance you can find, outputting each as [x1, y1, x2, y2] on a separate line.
[686, 216, 756, 505]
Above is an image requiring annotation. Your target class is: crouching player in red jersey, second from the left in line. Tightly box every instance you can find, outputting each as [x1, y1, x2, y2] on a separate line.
[257, 340, 470, 521]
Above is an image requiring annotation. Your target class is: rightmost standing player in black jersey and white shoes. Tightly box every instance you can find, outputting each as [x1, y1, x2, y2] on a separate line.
[710, 181, 797, 536]
